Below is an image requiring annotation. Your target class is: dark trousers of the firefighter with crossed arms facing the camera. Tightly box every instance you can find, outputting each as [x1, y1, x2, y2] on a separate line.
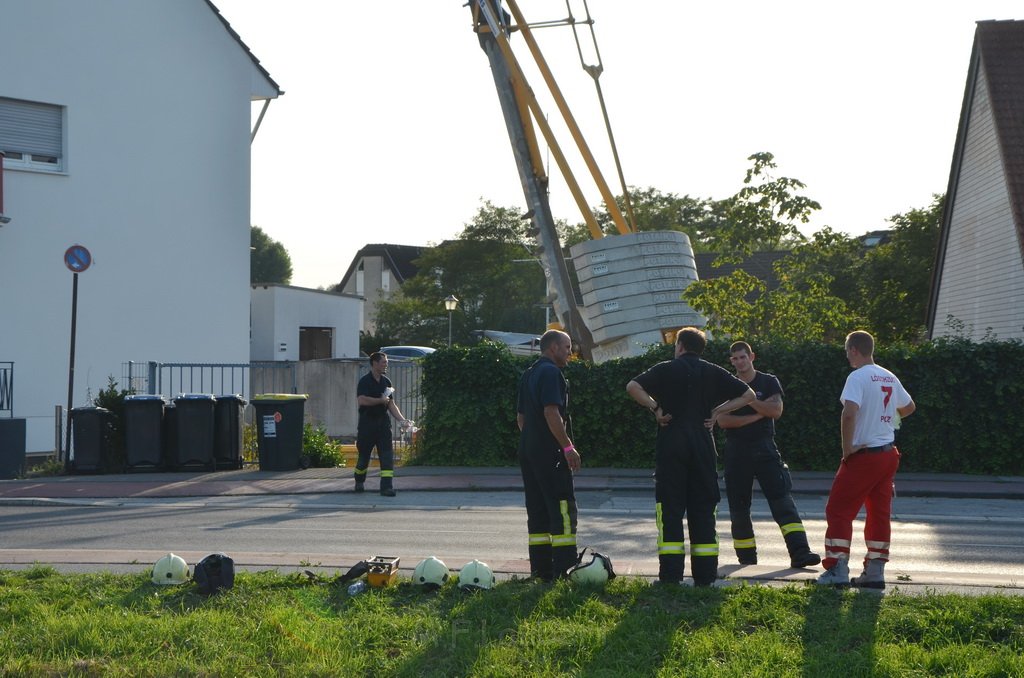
[725, 438, 810, 562]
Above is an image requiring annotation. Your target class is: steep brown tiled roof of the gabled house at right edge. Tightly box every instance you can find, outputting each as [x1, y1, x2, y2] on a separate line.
[928, 20, 1024, 333]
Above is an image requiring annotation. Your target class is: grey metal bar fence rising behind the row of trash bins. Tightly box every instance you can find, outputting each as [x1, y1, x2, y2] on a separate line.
[121, 361, 298, 399]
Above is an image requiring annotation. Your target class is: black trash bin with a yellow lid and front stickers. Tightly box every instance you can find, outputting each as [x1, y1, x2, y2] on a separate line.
[253, 393, 309, 471]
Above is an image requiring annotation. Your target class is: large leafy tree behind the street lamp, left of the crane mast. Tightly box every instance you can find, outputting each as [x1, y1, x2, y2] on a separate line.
[377, 201, 545, 346]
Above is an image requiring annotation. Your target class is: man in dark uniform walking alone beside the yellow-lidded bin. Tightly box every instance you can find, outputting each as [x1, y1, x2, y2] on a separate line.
[354, 352, 409, 497]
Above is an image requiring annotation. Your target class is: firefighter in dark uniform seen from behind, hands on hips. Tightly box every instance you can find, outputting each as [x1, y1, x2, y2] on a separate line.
[626, 328, 754, 586]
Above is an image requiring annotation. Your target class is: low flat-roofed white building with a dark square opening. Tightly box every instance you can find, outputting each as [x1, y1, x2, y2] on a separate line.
[250, 283, 362, 361]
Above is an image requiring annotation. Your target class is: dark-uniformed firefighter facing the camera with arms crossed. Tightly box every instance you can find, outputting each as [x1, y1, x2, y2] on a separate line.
[718, 341, 821, 567]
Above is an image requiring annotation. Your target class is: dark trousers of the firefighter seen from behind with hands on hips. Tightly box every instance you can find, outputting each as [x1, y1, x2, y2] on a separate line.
[654, 423, 722, 586]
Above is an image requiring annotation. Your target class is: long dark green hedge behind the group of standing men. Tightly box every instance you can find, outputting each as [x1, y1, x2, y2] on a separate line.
[417, 340, 1024, 474]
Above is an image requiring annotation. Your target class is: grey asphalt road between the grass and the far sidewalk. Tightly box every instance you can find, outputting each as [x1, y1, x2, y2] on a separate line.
[0, 492, 1024, 591]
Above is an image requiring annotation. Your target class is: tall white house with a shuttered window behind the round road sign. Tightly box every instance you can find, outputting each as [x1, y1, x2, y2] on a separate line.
[0, 0, 283, 453]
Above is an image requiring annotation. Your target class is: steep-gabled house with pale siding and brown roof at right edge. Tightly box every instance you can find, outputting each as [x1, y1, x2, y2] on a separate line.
[928, 22, 1024, 340]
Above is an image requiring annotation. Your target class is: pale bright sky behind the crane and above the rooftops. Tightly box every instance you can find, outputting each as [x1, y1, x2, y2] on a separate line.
[213, 0, 1024, 289]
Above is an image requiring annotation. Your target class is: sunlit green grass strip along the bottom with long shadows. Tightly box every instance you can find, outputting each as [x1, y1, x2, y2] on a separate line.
[0, 566, 1024, 678]
